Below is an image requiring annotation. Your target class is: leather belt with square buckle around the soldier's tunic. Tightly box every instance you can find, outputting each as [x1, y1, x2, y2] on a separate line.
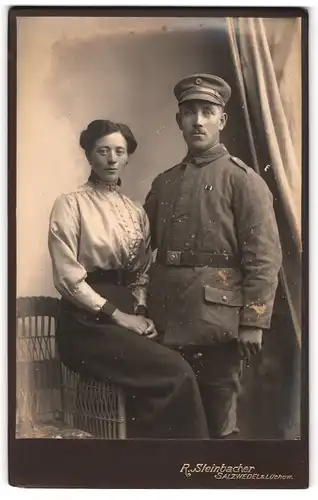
[156, 250, 240, 268]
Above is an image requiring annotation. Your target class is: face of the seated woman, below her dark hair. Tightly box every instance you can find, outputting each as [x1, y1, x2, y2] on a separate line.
[89, 132, 128, 182]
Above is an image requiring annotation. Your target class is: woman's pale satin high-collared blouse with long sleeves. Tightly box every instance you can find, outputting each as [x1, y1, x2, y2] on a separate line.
[48, 180, 152, 312]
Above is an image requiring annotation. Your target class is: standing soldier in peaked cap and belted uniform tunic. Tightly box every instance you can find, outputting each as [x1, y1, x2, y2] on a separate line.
[145, 74, 281, 438]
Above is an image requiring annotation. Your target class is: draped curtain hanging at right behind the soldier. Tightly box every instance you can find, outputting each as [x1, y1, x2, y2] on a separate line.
[227, 18, 302, 439]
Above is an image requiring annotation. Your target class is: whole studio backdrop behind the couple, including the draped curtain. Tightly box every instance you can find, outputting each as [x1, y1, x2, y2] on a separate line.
[17, 17, 301, 439]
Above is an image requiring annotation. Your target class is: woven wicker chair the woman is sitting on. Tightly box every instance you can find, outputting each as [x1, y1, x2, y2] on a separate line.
[16, 297, 126, 439]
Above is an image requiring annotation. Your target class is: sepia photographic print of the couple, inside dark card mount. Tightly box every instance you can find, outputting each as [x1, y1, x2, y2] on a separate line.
[11, 5, 307, 484]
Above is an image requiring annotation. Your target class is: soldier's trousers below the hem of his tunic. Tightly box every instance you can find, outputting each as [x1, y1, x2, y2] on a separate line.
[179, 341, 242, 438]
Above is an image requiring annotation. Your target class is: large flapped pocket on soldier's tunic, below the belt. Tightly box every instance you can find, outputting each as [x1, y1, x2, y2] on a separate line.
[202, 285, 244, 341]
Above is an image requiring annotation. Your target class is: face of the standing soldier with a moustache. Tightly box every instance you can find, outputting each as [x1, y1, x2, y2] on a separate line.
[177, 100, 227, 152]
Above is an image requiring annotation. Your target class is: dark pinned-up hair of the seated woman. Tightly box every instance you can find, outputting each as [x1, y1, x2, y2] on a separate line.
[80, 120, 137, 156]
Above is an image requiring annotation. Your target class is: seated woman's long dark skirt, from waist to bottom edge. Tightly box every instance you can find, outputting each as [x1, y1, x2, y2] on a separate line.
[56, 285, 208, 439]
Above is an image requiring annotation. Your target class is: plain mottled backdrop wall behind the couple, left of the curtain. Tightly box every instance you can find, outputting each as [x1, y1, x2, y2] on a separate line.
[17, 18, 250, 296]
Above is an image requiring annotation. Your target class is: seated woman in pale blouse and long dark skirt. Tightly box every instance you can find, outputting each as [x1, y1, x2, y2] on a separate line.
[49, 120, 208, 439]
